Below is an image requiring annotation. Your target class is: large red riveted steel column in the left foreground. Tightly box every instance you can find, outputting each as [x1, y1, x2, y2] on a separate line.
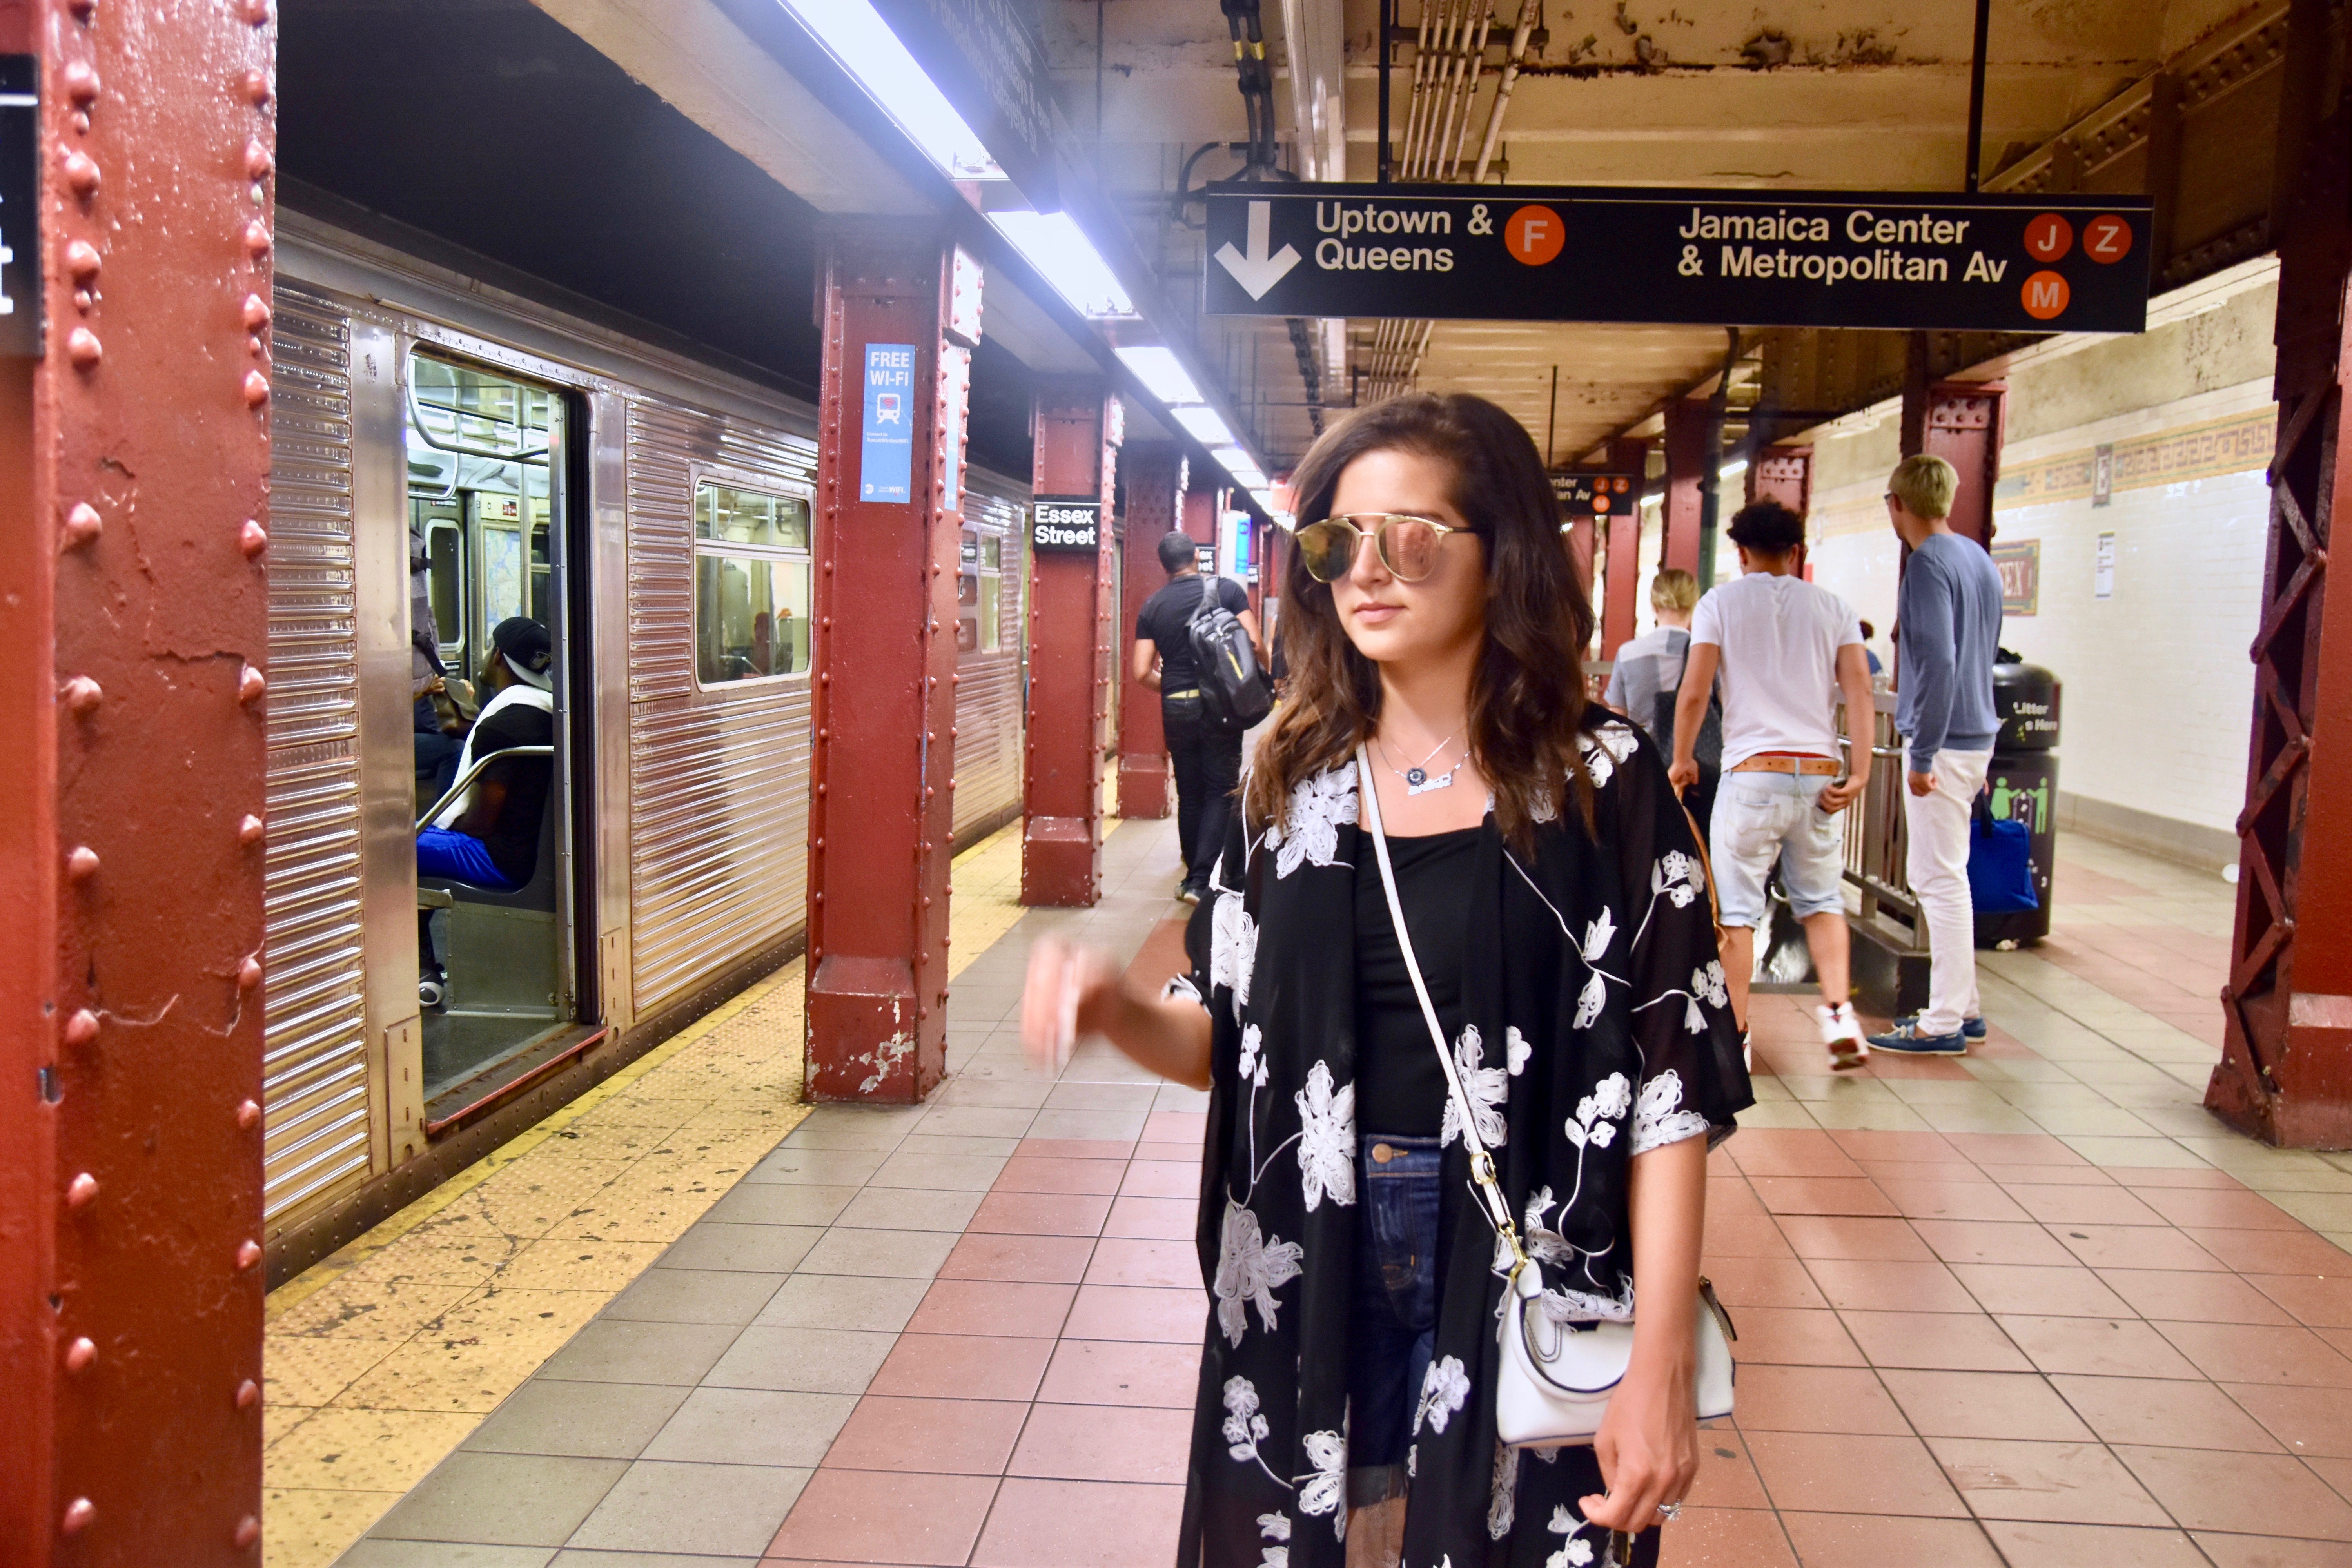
[0, 0, 275, 1568]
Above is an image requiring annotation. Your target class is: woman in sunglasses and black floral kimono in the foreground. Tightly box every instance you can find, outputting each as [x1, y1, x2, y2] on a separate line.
[1021, 395, 1752, 1568]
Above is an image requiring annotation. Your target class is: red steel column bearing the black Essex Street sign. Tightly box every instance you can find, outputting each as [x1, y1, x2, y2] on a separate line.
[1021, 379, 1120, 910]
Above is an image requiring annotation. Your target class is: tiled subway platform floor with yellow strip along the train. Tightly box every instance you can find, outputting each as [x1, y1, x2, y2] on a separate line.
[266, 823, 2352, 1568]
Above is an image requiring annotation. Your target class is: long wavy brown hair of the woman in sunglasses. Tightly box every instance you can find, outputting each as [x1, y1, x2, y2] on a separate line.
[1244, 392, 1592, 851]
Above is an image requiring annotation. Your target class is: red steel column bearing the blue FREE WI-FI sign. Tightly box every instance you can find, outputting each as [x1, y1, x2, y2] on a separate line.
[807, 223, 981, 1105]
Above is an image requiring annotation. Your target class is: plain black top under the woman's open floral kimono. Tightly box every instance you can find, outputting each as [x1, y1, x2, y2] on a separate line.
[1355, 828, 1479, 1138]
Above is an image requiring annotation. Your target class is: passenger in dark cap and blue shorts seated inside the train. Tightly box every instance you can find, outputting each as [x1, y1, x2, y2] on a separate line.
[416, 616, 555, 893]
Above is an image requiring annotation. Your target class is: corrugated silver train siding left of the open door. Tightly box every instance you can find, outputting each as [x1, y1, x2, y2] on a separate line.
[261, 285, 369, 1218]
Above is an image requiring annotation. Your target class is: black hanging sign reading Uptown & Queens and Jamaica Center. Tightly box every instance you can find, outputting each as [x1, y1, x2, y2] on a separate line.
[1207, 186, 2150, 332]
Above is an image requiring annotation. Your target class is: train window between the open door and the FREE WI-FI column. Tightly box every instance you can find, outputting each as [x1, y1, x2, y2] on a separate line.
[694, 482, 809, 686]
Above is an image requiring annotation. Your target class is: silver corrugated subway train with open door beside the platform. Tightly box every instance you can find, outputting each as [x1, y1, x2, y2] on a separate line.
[263, 212, 1030, 1274]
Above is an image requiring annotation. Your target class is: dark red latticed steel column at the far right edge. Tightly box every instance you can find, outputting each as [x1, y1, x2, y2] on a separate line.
[2206, 24, 2352, 1150]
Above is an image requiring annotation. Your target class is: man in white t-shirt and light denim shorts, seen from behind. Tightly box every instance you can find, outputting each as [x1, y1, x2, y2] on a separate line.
[1670, 501, 1872, 1072]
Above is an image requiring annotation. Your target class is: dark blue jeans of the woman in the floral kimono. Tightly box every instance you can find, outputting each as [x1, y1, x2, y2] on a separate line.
[1348, 1133, 1444, 1507]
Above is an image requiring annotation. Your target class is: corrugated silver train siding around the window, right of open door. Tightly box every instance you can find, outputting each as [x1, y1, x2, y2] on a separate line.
[628, 399, 816, 1018]
